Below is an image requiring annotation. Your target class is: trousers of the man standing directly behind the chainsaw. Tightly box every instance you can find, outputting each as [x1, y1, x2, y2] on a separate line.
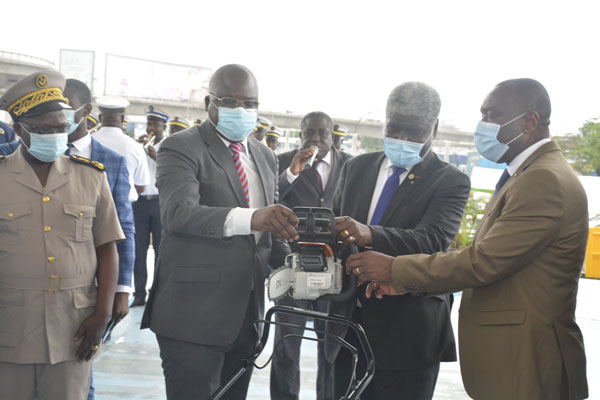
[271, 297, 333, 400]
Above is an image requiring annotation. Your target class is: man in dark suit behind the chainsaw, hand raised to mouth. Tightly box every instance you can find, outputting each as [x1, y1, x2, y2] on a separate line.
[271, 111, 352, 400]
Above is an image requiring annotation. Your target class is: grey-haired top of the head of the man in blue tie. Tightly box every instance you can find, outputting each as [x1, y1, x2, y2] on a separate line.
[385, 82, 442, 137]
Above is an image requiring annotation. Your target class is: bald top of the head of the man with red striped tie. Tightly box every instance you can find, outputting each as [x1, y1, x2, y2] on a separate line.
[208, 64, 258, 98]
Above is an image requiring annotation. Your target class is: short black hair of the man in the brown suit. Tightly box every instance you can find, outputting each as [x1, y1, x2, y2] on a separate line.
[494, 78, 552, 127]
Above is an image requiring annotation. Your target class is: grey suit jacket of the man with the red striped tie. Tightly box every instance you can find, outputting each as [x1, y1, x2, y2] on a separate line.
[142, 122, 278, 346]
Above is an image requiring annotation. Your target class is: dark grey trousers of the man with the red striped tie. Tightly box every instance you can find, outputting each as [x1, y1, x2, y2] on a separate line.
[156, 292, 259, 400]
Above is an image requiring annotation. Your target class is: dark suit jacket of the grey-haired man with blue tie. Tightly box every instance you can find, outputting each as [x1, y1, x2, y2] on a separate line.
[330, 152, 471, 370]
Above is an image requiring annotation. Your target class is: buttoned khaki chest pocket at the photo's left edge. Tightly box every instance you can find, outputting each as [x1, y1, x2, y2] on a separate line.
[0, 203, 32, 248]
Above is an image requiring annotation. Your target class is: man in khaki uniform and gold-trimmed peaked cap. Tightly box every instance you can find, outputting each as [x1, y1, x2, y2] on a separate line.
[0, 71, 125, 400]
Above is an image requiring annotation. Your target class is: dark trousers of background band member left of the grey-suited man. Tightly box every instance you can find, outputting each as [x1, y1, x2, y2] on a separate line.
[132, 196, 162, 299]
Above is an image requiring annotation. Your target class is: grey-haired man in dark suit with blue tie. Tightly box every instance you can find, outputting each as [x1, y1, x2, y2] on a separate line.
[328, 82, 470, 400]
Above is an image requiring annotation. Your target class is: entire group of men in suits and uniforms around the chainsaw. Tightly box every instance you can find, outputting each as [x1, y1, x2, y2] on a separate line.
[0, 64, 587, 400]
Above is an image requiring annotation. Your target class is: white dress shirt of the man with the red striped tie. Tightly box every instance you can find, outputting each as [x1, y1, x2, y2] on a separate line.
[219, 136, 267, 238]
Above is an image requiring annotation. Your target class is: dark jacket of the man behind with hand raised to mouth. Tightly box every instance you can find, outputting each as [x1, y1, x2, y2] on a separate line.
[277, 147, 352, 208]
